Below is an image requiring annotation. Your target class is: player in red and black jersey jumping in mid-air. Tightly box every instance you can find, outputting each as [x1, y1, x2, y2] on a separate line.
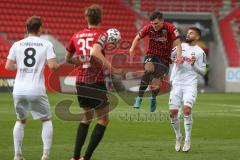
[129, 11, 182, 112]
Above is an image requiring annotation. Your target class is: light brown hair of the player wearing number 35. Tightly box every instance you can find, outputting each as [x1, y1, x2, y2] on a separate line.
[85, 4, 102, 25]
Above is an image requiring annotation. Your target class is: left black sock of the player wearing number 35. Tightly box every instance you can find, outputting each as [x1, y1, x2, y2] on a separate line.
[73, 123, 89, 159]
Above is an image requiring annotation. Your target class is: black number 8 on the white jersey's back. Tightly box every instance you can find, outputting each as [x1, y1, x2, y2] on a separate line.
[24, 48, 36, 67]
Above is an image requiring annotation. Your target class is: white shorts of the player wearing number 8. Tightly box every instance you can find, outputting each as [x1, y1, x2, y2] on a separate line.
[13, 95, 51, 120]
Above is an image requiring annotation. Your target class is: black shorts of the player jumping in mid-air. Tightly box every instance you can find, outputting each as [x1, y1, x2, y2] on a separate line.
[144, 56, 169, 78]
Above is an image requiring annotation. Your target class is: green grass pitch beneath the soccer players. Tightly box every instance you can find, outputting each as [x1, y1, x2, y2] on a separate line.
[0, 93, 240, 160]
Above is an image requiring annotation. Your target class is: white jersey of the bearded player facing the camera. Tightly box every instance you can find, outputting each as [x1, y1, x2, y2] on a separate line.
[170, 43, 206, 85]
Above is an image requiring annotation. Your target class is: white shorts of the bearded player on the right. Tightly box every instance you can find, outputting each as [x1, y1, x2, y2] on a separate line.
[169, 85, 197, 110]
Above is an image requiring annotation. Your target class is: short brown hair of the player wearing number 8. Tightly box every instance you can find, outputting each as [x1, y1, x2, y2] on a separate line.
[26, 16, 42, 33]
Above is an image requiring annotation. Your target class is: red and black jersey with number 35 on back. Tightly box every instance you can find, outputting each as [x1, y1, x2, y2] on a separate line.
[67, 28, 107, 83]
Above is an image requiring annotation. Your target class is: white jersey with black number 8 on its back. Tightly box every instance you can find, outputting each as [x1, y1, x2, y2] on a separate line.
[7, 36, 56, 95]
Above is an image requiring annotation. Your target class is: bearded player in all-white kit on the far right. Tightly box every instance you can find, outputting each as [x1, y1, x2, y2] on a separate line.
[169, 27, 206, 152]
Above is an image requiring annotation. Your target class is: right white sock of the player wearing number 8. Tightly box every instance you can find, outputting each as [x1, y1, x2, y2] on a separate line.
[42, 121, 53, 156]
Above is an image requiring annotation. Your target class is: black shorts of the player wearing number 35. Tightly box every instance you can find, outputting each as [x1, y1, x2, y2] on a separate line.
[76, 82, 109, 108]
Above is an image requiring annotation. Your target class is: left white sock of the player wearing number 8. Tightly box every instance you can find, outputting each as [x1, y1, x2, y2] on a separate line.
[13, 121, 25, 156]
